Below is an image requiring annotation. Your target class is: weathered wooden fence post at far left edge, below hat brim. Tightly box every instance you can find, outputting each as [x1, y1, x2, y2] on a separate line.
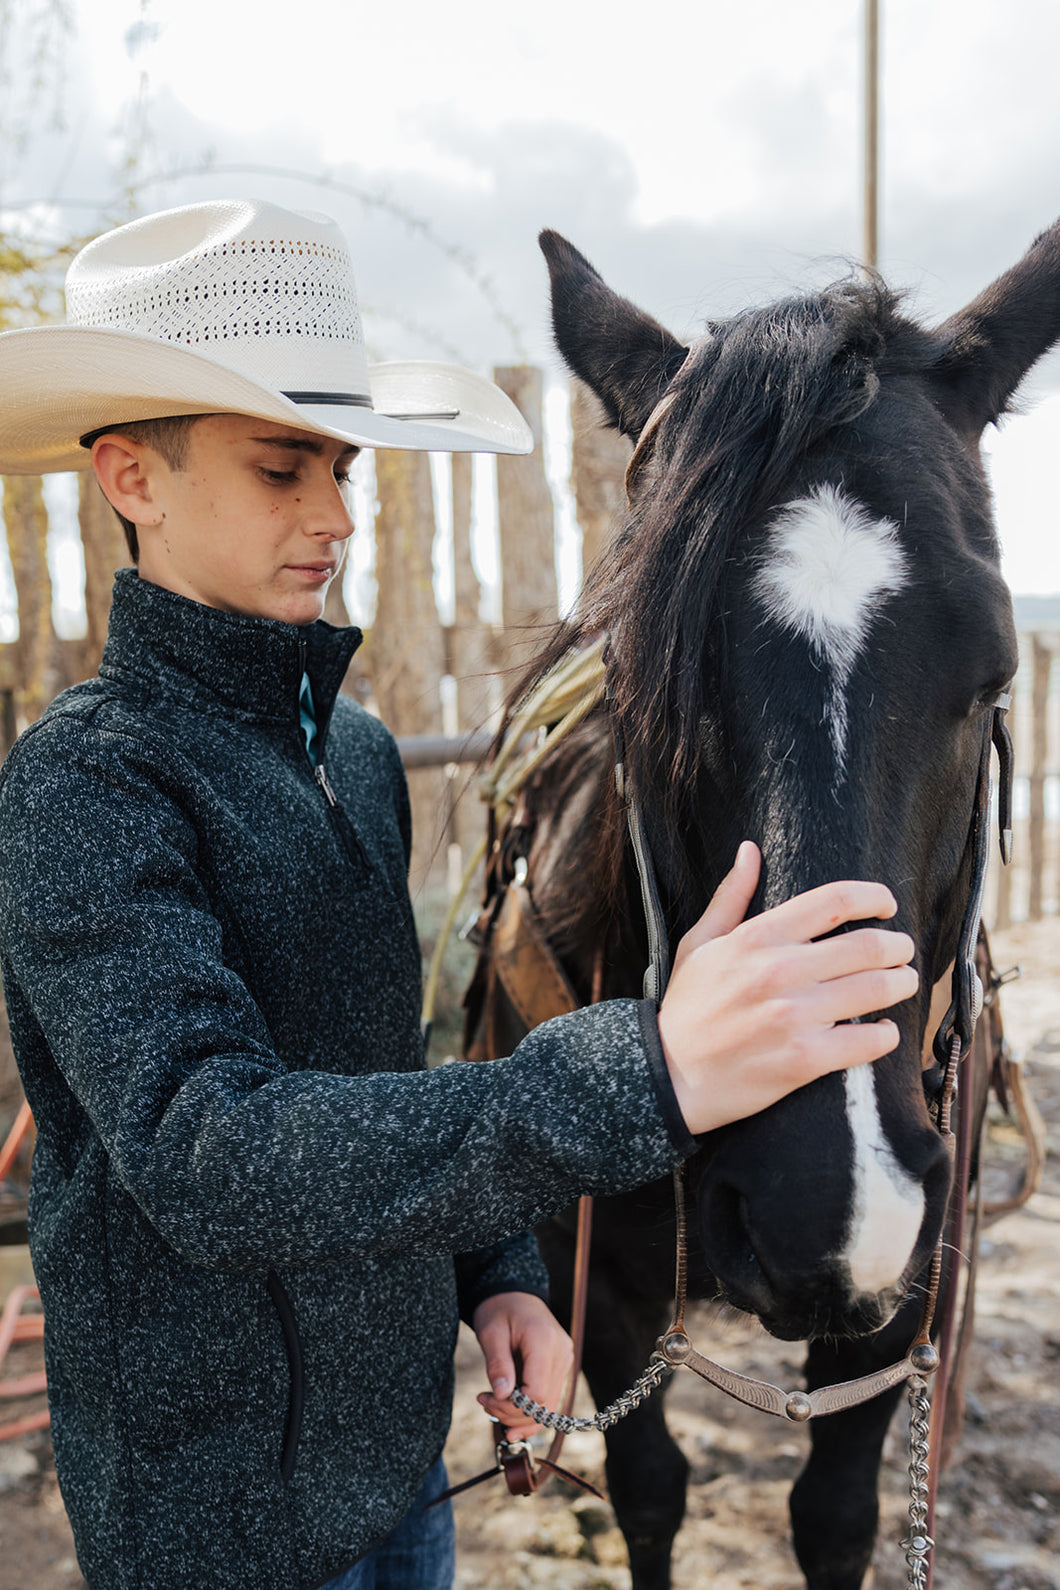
[3, 475, 62, 727]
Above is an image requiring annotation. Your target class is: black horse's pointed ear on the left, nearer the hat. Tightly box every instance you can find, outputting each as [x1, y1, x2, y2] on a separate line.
[537, 232, 688, 442]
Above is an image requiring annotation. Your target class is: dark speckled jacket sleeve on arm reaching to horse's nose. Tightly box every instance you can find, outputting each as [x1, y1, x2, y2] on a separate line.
[0, 727, 694, 1270]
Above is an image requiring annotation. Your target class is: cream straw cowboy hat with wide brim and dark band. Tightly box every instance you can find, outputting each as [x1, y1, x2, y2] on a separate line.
[0, 199, 534, 474]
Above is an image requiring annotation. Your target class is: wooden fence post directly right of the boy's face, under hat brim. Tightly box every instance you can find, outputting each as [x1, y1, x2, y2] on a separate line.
[369, 448, 445, 897]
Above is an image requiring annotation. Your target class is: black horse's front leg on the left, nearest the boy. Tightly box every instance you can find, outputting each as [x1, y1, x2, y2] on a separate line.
[539, 1224, 688, 1590]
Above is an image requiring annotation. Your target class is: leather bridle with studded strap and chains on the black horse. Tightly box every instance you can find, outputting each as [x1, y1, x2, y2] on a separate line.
[512, 690, 1012, 1590]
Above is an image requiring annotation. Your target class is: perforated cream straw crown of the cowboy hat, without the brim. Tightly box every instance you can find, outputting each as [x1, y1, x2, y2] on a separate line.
[67, 199, 369, 399]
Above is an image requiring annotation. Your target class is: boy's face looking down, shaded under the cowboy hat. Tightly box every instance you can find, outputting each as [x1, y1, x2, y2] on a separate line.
[128, 413, 356, 623]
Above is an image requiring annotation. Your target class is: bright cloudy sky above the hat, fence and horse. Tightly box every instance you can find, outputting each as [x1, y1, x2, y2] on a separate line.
[0, 0, 1060, 593]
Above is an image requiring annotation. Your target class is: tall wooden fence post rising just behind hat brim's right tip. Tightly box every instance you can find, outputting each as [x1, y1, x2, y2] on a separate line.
[493, 364, 559, 669]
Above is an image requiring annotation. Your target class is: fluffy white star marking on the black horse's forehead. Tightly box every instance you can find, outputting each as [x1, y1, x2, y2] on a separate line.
[753, 485, 906, 778]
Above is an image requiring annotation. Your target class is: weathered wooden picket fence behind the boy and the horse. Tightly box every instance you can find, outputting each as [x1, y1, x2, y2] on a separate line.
[0, 366, 1060, 925]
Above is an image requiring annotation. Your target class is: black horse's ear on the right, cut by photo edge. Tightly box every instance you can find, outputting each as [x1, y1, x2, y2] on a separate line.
[938, 221, 1060, 436]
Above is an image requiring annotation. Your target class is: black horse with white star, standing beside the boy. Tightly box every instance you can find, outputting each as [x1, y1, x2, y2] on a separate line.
[470, 223, 1060, 1590]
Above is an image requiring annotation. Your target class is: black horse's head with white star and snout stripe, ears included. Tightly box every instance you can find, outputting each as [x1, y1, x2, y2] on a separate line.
[542, 223, 1060, 1337]
